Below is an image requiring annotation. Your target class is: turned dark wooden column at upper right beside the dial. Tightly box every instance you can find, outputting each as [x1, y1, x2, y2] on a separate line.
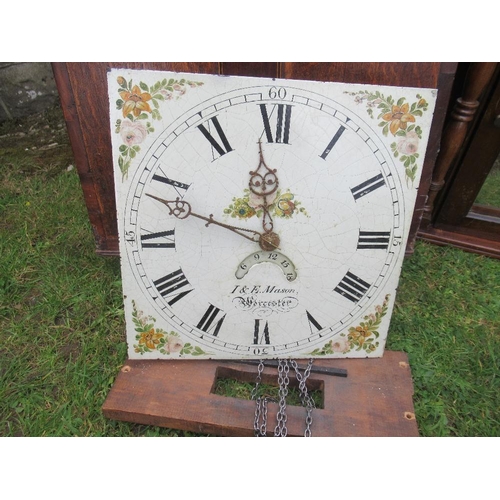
[422, 62, 497, 227]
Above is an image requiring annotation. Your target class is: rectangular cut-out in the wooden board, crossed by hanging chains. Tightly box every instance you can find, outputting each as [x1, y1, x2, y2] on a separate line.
[211, 366, 324, 408]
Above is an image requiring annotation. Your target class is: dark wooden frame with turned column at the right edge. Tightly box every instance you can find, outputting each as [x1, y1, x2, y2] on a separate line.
[417, 63, 500, 258]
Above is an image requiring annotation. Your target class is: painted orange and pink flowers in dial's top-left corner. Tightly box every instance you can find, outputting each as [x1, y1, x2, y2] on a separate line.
[115, 76, 203, 179]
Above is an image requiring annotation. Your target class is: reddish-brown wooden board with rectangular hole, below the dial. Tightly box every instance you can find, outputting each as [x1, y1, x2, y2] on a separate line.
[103, 351, 418, 437]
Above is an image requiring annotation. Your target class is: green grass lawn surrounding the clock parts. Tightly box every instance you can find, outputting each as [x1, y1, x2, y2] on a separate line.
[0, 109, 500, 436]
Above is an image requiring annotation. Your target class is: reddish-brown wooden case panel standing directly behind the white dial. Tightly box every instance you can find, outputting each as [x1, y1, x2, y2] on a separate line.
[52, 62, 457, 255]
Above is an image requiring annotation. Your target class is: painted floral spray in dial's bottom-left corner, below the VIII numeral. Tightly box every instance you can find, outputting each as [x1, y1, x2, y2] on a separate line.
[132, 301, 207, 356]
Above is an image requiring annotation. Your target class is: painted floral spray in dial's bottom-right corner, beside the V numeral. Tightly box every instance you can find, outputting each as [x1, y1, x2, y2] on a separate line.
[311, 294, 390, 356]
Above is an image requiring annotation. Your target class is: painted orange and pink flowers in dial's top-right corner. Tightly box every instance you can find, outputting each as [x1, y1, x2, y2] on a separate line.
[348, 90, 429, 185]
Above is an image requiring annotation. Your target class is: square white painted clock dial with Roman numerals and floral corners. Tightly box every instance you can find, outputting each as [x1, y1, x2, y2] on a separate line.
[108, 70, 435, 359]
